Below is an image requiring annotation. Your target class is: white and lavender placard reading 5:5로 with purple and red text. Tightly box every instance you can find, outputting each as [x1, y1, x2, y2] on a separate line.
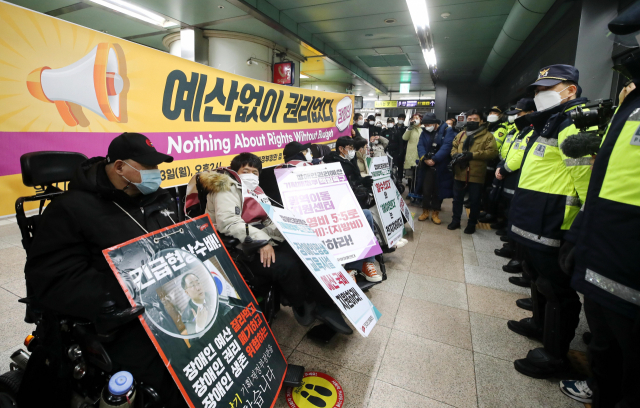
[275, 163, 382, 264]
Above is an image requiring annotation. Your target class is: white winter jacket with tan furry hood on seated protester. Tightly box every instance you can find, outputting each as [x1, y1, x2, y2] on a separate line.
[200, 171, 284, 245]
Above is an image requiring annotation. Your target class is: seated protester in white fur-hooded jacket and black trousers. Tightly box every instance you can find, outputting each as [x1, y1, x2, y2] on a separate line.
[200, 153, 353, 334]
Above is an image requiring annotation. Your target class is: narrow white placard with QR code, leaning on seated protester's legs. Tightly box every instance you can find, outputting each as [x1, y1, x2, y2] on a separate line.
[262, 204, 381, 337]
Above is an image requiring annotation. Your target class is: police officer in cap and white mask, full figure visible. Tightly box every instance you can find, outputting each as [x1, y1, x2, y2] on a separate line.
[508, 65, 591, 378]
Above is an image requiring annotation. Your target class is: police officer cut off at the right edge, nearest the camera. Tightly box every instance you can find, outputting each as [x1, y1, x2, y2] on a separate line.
[561, 3, 640, 408]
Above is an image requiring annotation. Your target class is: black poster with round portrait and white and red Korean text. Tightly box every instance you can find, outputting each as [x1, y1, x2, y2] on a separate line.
[103, 215, 287, 408]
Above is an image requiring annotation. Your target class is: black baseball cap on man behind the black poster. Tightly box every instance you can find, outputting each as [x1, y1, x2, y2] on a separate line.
[107, 132, 173, 166]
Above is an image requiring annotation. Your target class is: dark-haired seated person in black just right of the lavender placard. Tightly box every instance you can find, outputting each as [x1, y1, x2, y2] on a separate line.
[324, 136, 382, 282]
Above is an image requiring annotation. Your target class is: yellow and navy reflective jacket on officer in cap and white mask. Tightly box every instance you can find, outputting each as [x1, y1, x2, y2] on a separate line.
[509, 98, 591, 251]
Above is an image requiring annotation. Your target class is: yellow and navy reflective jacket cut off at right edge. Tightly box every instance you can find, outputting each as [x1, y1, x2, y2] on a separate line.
[571, 89, 640, 318]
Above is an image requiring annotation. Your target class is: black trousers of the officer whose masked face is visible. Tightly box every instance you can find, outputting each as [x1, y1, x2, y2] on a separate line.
[526, 248, 582, 358]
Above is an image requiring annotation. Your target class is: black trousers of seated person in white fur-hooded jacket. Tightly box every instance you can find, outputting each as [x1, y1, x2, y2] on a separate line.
[248, 242, 333, 306]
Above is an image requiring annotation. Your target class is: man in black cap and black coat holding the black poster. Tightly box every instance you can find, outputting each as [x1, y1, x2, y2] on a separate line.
[25, 133, 186, 407]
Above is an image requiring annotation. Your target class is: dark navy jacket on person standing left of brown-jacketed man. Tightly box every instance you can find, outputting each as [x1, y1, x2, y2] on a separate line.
[418, 123, 456, 199]
